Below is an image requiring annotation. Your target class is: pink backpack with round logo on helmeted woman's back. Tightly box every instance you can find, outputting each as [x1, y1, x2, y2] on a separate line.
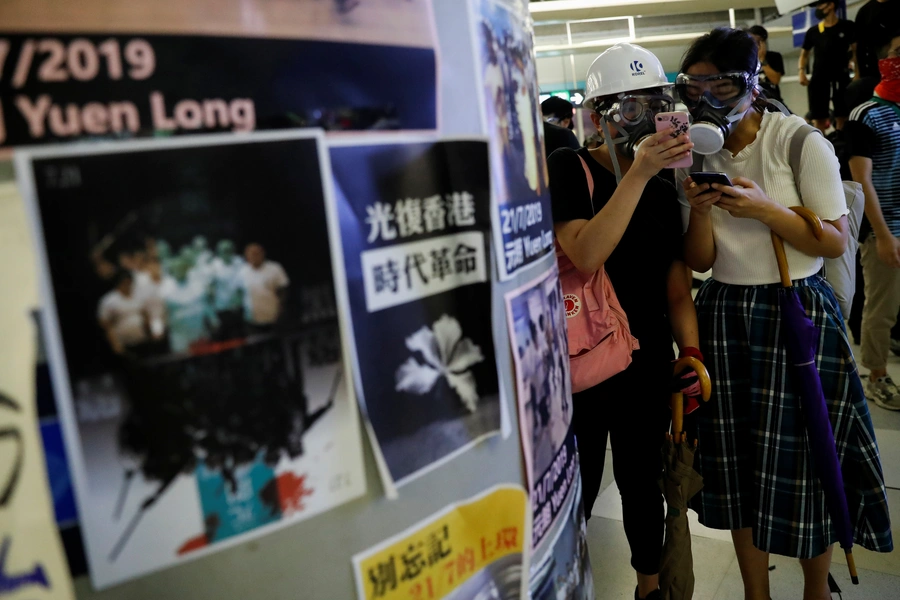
[556, 156, 640, 392]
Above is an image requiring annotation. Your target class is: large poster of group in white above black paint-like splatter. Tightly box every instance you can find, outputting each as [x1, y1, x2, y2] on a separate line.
[16, 131, 365, 588]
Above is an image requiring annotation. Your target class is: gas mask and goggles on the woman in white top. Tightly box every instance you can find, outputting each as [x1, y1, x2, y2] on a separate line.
[675, 72, 757, 155]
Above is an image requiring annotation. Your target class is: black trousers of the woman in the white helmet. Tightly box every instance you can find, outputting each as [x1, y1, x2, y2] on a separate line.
[572, 350, 672, 575]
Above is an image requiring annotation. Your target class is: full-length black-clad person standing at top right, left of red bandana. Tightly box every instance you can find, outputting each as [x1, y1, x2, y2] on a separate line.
[799, 0, 856, 132]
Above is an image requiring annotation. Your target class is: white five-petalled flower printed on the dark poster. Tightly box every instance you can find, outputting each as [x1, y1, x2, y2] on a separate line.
[395, 315, 484, 412]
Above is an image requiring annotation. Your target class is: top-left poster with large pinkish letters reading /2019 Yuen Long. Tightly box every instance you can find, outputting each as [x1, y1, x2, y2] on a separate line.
[0, 0, 437, 146]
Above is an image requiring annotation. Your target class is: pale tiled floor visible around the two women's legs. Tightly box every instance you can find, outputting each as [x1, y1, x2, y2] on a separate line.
[588, 340, 900, 600]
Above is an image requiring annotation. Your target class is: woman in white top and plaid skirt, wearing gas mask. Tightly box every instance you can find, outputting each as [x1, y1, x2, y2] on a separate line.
[677, 29, 893, 600]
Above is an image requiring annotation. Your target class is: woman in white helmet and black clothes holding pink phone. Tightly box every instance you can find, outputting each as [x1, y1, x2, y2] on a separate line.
[548, 44, 699, 598]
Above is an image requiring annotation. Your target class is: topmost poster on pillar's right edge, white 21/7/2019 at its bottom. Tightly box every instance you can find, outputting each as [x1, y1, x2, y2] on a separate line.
[468, 0, 553, 280]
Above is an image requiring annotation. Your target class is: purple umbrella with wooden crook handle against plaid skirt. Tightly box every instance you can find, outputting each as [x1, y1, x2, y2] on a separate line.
[772, 206, 859, 585]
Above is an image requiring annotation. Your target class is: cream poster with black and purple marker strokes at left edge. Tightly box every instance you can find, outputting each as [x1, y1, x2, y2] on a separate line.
[0, 181, 75, 600]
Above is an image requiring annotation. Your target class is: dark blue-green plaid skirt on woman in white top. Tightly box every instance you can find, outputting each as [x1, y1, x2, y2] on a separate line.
[686, 275, 893, 558]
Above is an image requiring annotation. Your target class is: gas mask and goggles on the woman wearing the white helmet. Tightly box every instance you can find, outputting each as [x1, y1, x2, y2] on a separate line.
[597, 92, 675, 181]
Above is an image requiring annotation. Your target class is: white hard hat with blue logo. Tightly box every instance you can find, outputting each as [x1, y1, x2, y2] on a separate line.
[582, 43, 672, 110]
